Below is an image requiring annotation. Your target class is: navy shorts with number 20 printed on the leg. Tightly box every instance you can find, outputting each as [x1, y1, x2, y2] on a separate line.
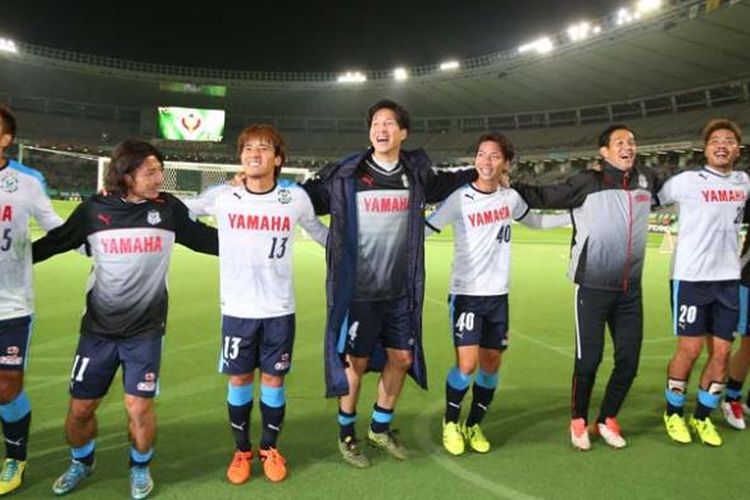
[670, 280, 740, 341]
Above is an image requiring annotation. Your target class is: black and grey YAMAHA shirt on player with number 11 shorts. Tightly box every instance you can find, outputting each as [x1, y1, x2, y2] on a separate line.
[32, 193, 218, 338]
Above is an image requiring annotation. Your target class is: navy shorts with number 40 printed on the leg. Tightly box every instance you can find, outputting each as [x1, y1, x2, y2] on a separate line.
[448, 294, 508, 351]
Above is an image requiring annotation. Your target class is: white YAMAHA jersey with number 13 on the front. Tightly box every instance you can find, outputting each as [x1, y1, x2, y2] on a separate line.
[185, 180, 328, 319]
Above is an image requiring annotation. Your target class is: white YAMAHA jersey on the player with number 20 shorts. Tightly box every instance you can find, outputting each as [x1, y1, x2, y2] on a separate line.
[658, 167, 750, 281]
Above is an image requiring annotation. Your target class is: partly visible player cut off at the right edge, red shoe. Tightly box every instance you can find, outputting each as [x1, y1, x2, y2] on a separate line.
[721, 211, 750, 430]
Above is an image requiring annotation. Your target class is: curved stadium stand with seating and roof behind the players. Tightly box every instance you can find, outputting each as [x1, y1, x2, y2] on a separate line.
[0, 0, 750, 190]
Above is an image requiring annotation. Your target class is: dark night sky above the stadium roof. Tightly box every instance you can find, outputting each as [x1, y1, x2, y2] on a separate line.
[0, 0, 622, 71]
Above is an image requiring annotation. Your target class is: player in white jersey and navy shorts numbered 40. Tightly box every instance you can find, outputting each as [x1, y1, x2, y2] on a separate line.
[427, 133, 570, 455]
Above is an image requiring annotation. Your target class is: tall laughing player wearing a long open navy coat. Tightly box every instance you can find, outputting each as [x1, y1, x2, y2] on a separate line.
[302, 99, 476, 467]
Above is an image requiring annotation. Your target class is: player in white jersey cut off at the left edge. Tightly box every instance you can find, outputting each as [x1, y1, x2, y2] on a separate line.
[0, 106, 62, 495]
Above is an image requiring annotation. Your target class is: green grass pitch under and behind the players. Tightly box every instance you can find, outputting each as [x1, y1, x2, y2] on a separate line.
[22, 203, 750, 500]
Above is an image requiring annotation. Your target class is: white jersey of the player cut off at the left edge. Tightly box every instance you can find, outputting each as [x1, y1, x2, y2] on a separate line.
[0, 162, 62, 320]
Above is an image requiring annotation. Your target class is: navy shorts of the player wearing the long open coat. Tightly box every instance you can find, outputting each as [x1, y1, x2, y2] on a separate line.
[338, 297, 416, 358]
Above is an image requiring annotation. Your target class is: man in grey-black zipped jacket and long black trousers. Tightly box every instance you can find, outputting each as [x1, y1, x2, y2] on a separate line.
[512, 125, 660, 449]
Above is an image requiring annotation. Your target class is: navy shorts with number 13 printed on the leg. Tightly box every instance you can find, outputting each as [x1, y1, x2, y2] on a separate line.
[219, 314, 294, 375]
